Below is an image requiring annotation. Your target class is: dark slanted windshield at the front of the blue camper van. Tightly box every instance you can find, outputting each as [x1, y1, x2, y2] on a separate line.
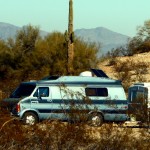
[10, 83, 36, 98]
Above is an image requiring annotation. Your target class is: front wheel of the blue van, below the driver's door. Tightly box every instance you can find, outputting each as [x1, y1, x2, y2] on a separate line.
[23, 112, 38, 125]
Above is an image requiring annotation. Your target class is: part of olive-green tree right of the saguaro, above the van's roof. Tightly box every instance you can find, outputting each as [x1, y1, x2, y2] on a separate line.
[73, 38, 100, 74]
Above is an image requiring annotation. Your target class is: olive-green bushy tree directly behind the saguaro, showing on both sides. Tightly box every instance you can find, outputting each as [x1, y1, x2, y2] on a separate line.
[35, 32, 99, 75]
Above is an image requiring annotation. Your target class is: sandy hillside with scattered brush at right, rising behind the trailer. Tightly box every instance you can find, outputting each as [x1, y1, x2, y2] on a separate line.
[99, 20, 150, 92]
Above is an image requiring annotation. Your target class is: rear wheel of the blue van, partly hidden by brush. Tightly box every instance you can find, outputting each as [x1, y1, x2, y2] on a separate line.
[88, 113, 104, 127]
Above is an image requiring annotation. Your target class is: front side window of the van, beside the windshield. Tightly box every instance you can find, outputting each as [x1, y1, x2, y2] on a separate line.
[33, 87, 49, 97]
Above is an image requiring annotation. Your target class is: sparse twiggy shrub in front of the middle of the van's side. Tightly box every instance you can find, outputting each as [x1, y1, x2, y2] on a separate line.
[59, 85, 92, 123]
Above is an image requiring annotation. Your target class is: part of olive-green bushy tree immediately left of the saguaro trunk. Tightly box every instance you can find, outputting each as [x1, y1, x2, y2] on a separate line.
[33, 32, 67, 75]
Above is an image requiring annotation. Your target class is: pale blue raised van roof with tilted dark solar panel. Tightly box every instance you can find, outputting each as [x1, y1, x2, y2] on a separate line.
[23, 69, 121, 86]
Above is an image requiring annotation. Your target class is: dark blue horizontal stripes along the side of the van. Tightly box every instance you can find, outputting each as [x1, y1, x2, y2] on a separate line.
[33, 99, 128, 114]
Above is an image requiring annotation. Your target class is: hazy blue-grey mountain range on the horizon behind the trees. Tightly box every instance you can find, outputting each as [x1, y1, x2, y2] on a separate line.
[0, 22, 130, 56]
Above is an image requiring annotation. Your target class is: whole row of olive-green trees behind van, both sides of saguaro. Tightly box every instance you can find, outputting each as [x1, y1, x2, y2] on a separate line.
[0, 25, 99, 93]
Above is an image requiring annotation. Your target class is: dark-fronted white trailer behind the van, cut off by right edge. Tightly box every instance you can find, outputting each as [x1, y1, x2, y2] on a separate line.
[128, 83, 150, 122]
